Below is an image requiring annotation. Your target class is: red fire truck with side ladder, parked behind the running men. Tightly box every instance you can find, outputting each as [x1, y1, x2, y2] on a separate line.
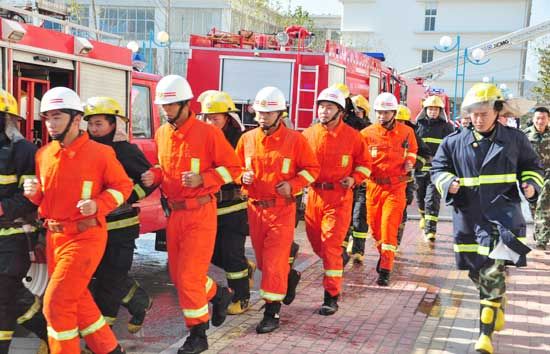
[187, 26, 424, 129]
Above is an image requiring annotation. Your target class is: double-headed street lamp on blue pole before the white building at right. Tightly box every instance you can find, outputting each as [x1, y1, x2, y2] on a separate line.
[434, 34, 490, 120]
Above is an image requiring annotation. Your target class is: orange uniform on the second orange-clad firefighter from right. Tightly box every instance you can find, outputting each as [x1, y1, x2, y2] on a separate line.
[304, 122, 371, 296]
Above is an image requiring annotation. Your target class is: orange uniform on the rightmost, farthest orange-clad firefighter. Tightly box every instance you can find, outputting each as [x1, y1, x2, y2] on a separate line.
[361, 121, 418, 271]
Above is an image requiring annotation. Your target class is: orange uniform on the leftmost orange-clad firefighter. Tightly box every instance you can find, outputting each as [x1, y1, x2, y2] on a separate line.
[29, 133, 133, 354]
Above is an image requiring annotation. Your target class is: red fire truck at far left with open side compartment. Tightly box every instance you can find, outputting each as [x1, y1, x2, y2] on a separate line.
[0, 5, 166, 233]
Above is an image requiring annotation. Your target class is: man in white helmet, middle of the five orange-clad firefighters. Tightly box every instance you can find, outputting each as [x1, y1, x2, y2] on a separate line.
[237, 87, 319, 333]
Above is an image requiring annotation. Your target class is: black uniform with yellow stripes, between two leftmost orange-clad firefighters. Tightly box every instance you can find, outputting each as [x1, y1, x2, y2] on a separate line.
[91, 132, 155, 325]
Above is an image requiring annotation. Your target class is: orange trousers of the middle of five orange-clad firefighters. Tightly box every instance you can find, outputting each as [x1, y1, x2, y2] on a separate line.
[248, 203, 296, 302]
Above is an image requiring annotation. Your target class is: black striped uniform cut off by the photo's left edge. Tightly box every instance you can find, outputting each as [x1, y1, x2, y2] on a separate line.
[0, 133, 47, 354]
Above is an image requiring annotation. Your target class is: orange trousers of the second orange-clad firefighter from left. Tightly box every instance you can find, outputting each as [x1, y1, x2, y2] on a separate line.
[166, 200, 217, 327]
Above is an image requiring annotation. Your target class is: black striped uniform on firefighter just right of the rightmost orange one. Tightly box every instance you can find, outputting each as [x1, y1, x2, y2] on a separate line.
[414, 108, 455, 234]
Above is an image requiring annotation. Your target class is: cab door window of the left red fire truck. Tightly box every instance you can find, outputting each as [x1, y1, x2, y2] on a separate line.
[132, 85, 153, 139]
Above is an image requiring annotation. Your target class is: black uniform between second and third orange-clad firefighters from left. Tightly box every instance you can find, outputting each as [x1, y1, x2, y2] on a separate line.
[212, 119, 250, 302]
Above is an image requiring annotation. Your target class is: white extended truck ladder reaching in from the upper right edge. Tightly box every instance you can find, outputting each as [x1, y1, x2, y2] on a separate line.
[400, 20, 550, 78]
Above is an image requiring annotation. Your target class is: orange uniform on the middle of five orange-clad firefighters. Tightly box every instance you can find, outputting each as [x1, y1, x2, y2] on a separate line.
[237, 124, 319, 302]
